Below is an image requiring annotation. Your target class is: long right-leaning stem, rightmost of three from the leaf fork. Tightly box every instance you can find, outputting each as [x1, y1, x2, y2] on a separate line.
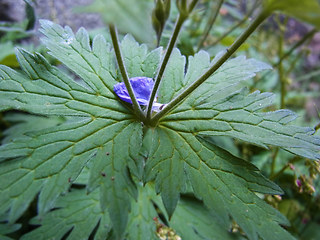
[151, 11, 270, 126]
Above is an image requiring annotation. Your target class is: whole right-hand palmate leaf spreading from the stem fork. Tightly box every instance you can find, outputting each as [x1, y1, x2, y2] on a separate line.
[145, 50, 320, 239]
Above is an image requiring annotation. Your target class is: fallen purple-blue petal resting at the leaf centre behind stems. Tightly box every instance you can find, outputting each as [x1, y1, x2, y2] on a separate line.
[113, 77, 164, 111]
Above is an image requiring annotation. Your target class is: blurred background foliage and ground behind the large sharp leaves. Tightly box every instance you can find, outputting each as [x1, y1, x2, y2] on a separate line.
[0, 0, 320, 240]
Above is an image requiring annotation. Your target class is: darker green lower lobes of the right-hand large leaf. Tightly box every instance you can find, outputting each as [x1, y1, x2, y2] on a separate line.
[146, 127, 292, 239]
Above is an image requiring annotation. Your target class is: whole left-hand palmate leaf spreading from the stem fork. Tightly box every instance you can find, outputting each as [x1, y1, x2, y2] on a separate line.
[0, 21, 157, 237]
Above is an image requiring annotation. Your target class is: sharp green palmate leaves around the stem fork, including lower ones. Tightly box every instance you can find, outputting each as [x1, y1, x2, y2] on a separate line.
[0, 11, 320, 240]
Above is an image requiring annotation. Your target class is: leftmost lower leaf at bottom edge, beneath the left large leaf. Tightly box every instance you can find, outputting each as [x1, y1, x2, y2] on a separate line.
[21, 190, 111, 240]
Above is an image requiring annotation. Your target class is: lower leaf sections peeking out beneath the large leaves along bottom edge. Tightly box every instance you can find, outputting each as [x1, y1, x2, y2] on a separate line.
[21, 184, 235, 240]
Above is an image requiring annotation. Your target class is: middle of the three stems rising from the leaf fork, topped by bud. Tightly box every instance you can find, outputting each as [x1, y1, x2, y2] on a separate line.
[147, 0, 198, 119]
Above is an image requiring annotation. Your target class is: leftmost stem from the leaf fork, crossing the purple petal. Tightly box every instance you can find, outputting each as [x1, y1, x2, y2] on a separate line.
[109, 24, 145, 121]
